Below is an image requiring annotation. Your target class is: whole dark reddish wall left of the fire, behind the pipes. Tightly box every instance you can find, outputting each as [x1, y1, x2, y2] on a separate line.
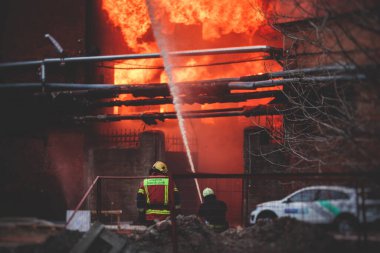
[0, 0, 86, 220]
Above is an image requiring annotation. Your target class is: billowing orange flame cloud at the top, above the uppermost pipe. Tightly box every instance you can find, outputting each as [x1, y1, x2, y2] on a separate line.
[102, 0, 265, 48]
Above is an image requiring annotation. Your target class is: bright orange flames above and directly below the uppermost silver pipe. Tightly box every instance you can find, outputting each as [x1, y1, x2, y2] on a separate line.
[102, 0, 274, 84]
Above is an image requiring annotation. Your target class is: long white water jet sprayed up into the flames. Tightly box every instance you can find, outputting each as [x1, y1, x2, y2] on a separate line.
[146, 0, 202, 203]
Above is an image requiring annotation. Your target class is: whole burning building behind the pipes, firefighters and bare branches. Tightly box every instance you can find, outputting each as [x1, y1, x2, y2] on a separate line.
[0, 0, 378, 243]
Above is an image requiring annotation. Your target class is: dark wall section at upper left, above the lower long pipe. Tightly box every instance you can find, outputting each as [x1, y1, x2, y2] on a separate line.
[0, 0, 86, 82]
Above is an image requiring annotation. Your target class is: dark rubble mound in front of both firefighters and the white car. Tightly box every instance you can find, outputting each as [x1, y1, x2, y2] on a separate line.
[128, 216, 338, 253]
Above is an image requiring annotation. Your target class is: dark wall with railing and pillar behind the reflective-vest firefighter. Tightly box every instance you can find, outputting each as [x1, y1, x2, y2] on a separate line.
[86, 131, 165, 220]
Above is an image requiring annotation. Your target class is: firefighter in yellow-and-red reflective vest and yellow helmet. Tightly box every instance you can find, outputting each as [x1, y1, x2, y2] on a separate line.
[137, 161, 181, 225]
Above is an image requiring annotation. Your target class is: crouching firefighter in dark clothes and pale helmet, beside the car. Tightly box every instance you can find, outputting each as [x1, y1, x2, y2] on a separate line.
[198, 188, 229, 233]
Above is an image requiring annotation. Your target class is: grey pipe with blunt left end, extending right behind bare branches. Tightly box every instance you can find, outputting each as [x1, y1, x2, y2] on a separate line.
[228, 74, 366, 90]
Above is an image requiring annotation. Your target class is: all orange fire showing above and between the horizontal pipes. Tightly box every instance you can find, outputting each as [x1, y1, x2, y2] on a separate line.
[101, 0, 281, 130]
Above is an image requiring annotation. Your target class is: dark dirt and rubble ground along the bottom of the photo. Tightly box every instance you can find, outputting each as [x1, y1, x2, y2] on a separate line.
[0, 216, 380, 253]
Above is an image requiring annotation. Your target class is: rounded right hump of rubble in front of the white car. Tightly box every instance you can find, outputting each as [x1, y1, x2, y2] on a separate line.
[222, 218, 339, 253]
